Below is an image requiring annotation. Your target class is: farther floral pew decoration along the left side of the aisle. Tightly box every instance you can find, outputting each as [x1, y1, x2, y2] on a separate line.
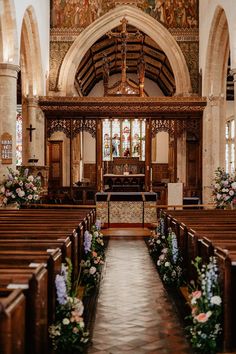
[80, 221, 105, 296]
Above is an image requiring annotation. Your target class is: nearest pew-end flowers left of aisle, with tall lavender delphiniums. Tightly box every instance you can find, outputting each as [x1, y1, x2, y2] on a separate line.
[49, 260, 89, 354]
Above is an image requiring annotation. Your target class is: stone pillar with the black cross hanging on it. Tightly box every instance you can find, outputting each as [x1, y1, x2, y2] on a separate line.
[23, 96, 39, 165]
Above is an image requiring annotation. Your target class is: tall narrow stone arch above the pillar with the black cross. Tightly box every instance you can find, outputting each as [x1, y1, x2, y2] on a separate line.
[20, 6, 43, 97]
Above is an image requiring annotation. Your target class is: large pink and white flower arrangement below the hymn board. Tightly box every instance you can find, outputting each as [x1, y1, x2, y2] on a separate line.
[0, 168, 41, 206]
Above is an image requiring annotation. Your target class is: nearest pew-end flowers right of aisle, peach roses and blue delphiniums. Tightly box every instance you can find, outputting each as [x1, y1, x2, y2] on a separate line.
[187, 257, 222, 354]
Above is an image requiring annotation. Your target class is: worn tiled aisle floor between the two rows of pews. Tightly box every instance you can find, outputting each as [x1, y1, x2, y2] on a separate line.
[89, 239, 191, 354]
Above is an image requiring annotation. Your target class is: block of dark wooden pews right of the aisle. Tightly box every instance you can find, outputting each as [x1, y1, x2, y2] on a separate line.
[162, 212, 236, 350]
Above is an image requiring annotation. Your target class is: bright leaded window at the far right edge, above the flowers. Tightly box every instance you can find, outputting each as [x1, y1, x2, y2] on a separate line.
[225, 119, 235, 173]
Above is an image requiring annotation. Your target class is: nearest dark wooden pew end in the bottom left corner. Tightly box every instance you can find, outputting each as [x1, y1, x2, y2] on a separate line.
[0, 288, 26, 354]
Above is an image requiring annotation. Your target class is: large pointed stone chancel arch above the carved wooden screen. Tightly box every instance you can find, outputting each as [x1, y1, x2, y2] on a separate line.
[58, 5, 191, 95]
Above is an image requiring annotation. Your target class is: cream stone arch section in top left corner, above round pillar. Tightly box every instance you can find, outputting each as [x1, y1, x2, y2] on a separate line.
[0, 0, 18, 64]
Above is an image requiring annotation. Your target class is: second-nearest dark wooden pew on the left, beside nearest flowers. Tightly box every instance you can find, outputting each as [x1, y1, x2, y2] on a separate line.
[0, 264, 48, 354]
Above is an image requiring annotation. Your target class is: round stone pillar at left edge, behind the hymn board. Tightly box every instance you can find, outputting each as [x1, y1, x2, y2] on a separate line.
[0, 63, 19, 179]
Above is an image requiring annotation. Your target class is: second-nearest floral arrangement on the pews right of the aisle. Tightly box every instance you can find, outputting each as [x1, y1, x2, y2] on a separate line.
[157, 229, 183, 287]
